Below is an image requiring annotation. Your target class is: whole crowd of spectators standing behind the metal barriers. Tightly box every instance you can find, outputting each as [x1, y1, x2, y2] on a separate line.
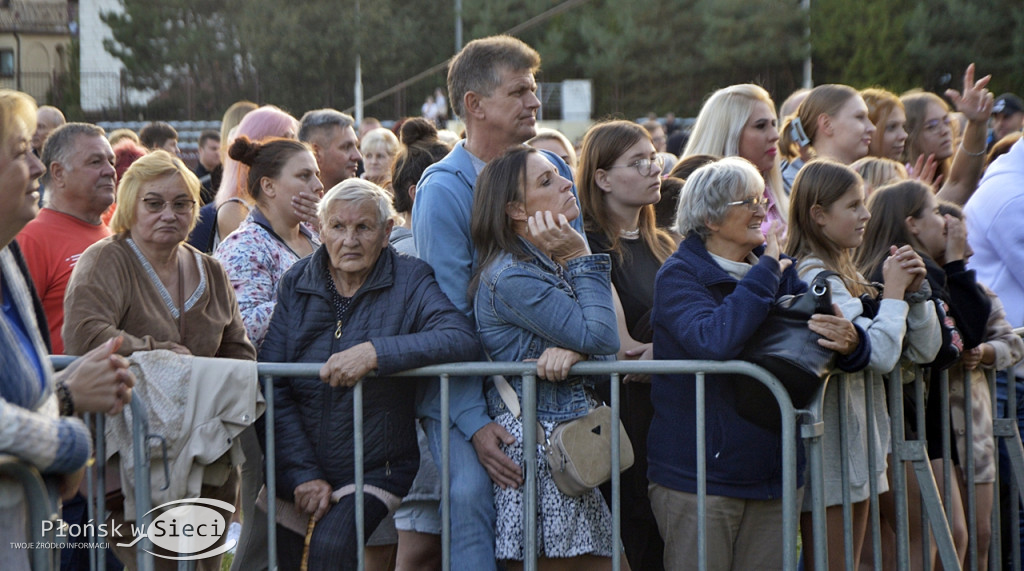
[0, 30, 1024, 570]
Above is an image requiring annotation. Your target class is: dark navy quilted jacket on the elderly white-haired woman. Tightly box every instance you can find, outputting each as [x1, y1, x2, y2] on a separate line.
[259, 247, 479, 499]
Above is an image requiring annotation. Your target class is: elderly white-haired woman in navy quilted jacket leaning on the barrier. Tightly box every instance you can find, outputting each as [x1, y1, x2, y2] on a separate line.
[260, 179, 479, 569]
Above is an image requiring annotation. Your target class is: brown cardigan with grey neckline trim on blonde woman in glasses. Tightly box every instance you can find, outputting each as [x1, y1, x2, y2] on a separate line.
[61, 234, 256, 360]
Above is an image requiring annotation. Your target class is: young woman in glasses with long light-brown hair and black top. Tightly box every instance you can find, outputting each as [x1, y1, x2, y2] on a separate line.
[577, 121, 675, 569]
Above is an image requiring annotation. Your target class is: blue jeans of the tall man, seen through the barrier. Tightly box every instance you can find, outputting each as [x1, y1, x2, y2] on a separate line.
[423, 418, 497, 571]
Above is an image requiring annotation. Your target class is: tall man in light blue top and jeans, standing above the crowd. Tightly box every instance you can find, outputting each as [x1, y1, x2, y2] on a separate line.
[413, 36, 583, 570]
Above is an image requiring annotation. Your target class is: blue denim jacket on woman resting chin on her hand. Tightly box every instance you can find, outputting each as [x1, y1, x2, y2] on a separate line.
[473, 238, 618, 422]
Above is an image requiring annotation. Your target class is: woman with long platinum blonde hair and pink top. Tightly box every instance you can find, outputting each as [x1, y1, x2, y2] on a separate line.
[682, 84, 790, 235]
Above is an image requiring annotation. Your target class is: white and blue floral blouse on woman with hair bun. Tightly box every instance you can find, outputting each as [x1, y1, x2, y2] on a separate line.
[213, 208, 321, 351]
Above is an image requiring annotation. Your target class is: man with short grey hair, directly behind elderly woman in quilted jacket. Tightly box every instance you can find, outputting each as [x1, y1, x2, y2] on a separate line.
[299, 108, 362, 192]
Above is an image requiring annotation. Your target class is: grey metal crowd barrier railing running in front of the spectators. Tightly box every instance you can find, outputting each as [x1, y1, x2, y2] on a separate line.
[51, 354, 1024, 570]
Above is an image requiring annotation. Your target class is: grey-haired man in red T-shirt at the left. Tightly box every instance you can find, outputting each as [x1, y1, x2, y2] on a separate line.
[16, 123, 116, 355]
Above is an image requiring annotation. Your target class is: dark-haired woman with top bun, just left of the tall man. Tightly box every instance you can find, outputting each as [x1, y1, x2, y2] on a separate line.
[390, 117, 452, 256]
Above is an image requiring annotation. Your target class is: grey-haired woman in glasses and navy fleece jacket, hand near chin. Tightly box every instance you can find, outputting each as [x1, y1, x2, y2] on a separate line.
[647, 157, 870, 570]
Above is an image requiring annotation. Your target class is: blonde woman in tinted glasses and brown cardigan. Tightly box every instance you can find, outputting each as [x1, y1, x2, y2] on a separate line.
[62, 150, 256, 569]
